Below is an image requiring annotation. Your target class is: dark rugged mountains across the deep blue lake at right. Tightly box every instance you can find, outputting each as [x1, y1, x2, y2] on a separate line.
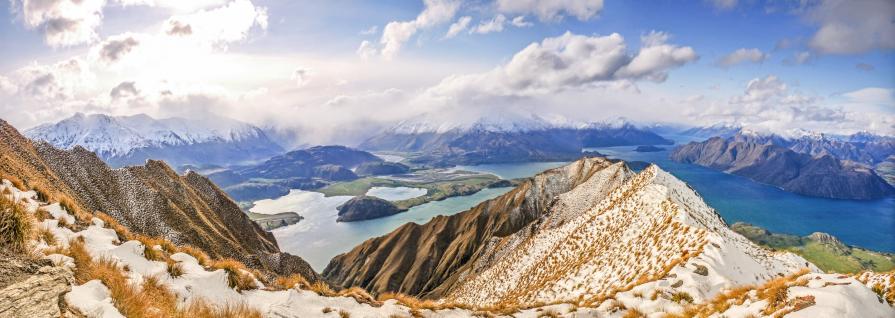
[671, 136, 895, 200]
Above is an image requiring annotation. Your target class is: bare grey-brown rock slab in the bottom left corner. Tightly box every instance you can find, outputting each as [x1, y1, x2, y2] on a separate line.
[0, 253, 74, 318]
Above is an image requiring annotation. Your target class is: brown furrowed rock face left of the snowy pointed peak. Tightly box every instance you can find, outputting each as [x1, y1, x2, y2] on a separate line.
[323, 158, 611, 298]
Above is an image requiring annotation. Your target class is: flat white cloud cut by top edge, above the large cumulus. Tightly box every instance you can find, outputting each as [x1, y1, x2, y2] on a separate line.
[497, 0, 603, 21]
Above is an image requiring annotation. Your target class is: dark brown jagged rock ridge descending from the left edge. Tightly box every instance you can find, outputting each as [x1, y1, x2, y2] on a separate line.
[0, 120, 319, 281]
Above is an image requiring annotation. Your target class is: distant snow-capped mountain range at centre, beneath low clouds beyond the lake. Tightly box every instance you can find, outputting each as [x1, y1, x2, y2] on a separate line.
[359, 115, 673, 166]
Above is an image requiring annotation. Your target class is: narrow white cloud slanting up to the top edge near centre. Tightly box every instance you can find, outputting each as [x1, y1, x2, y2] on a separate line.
[379, 0, 460, 59]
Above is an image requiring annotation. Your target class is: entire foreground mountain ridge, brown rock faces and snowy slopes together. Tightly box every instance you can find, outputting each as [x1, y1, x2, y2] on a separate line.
[0, 122, 895, 318]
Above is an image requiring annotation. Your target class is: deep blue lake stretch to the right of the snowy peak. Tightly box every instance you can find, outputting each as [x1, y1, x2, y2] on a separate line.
[588, 147, 895, 252]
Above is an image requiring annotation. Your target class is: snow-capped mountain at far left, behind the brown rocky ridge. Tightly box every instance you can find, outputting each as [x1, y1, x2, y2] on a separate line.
[24, 113, 283, 166]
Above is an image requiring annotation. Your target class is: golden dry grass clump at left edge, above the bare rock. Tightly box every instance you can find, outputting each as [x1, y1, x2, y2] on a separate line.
[0, 195, 34, 252]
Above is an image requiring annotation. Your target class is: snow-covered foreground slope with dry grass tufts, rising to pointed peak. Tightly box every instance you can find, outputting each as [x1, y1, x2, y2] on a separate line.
[0, 159, 895, 318]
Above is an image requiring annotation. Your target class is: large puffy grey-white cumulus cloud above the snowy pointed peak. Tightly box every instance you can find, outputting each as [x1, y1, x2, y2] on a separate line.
[426, 32, 697, 103]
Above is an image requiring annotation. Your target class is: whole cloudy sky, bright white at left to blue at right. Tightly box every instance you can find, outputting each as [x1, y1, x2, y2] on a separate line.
[0, 0, 895, 144]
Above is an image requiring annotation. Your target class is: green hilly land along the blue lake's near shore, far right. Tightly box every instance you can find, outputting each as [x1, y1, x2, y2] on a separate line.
[731, 222, 895, 273]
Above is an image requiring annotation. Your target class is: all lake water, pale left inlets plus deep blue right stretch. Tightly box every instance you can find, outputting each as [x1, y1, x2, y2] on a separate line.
[251, 146, 895, 271]
